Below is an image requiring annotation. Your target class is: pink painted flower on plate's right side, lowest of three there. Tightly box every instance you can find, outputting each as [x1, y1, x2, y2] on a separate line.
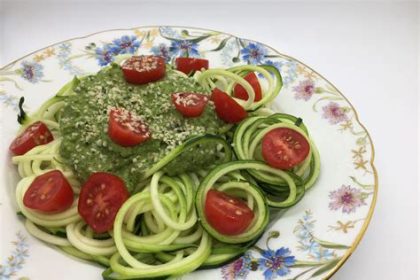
[329, 185, 366, 214]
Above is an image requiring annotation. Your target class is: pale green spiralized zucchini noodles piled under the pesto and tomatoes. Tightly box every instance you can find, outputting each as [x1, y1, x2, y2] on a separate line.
[12, 61, 320, 279]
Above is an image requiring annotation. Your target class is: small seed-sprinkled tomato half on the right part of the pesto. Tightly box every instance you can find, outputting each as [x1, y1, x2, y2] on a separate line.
[172, 92, 208, 118]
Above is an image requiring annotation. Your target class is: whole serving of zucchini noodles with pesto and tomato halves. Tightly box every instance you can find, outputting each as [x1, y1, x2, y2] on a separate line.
[9, 55, 320, 279]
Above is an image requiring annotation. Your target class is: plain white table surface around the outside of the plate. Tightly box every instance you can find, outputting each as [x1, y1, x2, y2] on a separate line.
[0, 0, 420, 280]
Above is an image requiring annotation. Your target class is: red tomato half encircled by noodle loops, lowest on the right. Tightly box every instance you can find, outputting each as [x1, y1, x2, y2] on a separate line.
[204, 190, 254, 235]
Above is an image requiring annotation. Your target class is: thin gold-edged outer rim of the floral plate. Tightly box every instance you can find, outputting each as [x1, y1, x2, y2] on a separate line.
[0, 25, 379, 279]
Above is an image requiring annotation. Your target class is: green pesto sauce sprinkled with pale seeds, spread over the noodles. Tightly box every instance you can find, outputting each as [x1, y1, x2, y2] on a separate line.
[60, 64, 225, 191]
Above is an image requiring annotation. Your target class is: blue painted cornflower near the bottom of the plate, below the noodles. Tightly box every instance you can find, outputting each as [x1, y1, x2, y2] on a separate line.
[258, 247, 296, 280]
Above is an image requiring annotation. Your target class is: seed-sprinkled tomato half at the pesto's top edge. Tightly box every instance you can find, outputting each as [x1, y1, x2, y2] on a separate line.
[121, 55, 166, 85]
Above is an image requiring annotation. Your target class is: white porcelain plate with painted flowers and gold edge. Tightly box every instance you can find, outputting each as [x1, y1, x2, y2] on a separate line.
[0, 26, 378, 280]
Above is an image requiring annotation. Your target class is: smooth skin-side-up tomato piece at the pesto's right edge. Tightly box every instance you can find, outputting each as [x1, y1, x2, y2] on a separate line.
[211, 88, 248, 123]
